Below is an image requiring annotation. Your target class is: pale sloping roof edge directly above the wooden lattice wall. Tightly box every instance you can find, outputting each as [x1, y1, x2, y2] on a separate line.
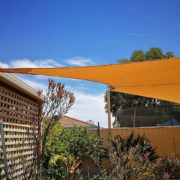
[0, 73, 43, 101]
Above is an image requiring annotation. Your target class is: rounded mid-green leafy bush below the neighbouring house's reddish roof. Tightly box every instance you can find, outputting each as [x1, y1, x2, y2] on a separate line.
[66, 126, 107, 166]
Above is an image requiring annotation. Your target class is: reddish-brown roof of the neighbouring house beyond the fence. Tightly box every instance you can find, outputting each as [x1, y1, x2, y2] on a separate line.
[59, 116, 97, 128]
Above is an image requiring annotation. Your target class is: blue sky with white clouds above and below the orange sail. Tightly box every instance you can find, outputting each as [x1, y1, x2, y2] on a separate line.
[0, 0, 180, 127]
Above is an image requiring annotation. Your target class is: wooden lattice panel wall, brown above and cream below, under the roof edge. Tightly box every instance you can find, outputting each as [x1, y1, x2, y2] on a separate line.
[0, 82, 40, 180]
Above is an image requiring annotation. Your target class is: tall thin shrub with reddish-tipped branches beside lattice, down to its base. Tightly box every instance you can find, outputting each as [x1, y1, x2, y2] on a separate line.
[31, 79, 75, 178]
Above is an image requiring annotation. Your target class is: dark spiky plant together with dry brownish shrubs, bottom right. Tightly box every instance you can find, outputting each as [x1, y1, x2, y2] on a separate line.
[94, 134, 180, 180]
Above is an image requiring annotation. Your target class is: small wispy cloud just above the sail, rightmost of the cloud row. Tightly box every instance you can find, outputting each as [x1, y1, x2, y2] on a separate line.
[65, 57, 96, 66]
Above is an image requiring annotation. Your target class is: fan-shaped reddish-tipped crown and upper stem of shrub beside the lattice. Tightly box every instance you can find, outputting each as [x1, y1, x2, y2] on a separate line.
[38, 79, 75, 160]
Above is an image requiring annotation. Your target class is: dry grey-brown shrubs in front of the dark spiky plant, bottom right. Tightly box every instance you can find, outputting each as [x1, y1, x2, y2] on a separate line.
[91, 147, 180, 180]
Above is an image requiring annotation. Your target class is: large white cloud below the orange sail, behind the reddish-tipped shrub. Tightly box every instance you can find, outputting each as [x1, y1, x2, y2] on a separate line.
[21, 77, 113, 127]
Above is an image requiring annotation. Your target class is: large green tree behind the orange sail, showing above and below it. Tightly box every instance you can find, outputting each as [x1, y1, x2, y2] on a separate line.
[104, 48, 174, 126]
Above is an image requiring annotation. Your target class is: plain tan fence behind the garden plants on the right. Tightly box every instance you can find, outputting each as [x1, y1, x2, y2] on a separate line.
[90, 126, 180, 159]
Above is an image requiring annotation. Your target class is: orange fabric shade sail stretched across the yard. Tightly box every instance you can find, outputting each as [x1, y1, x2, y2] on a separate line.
[0, 58, 180, 103]
